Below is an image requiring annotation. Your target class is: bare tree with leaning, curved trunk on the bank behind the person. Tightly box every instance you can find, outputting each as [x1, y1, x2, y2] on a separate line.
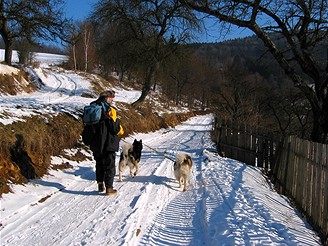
[92, 0, 201, 105]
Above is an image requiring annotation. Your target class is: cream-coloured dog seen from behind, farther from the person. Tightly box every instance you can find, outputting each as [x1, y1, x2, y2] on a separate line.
[173, 152, 192, 191]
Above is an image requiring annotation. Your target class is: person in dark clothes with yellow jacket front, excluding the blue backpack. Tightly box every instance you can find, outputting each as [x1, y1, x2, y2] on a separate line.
[90, 90, 124, 195]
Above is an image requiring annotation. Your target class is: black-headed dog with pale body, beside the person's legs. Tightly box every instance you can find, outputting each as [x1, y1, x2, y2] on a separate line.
[119, 139, 142, 181]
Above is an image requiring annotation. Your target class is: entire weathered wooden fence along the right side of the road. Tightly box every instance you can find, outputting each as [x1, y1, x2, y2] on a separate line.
[214, 118, 328, 245]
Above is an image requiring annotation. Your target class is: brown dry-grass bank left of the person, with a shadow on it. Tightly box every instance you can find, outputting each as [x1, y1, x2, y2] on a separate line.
[0, 114, 82, 194]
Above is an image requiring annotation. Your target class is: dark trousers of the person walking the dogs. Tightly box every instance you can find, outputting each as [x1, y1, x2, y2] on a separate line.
[96, 152, 116, 188]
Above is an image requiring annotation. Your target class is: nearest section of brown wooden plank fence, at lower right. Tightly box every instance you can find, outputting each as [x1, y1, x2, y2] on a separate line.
[271, 136, 328, 245]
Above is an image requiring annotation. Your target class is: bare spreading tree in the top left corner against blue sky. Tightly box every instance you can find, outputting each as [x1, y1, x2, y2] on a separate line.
[0, 0, 70, 65]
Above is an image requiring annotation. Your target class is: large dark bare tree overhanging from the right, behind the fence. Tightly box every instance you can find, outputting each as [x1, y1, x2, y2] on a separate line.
[180, 0, 328, 143]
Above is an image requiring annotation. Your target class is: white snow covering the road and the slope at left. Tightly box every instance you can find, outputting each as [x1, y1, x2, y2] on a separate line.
[0, 51, 320, 246]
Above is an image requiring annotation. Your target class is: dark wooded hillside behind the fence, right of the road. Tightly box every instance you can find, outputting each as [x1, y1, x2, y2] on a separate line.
[191, 35, 327, 139]
